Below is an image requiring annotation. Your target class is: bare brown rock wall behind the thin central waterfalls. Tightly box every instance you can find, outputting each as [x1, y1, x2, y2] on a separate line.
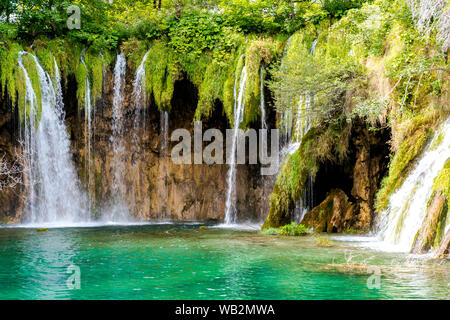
[70, 73, 271, 221]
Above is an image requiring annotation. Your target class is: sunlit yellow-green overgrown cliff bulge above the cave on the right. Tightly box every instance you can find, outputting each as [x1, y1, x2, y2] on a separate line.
[263, 1, 450, 228]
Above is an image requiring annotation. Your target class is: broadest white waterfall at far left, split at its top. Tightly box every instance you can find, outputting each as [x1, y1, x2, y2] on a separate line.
[18, 52, 89, 225]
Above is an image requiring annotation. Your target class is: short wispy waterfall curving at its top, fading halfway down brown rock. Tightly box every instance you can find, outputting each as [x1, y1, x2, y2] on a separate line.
[132, 50, 150, 144]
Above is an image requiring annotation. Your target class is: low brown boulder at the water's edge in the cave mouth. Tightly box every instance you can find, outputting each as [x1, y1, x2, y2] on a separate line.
[302, 189, 355, 233]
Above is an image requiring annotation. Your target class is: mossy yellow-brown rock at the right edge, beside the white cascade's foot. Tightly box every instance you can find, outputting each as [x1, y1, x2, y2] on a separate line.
[411, 192, 448, 254]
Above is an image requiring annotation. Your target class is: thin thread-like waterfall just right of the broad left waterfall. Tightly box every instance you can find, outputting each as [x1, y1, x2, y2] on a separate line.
[80, 49, 94, 212]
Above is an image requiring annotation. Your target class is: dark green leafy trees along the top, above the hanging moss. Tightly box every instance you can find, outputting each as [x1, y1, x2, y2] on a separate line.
[0, 0, 365, 49]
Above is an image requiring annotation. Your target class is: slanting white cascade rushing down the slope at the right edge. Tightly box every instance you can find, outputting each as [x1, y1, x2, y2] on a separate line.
[379, 118, 450, 251]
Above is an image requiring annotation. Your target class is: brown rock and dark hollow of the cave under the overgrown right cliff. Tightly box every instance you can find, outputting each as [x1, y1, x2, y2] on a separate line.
[301, 124, 389, 232]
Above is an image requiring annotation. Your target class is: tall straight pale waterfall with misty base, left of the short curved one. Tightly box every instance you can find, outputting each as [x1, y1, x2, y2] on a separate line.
[105, 53, 129, 222]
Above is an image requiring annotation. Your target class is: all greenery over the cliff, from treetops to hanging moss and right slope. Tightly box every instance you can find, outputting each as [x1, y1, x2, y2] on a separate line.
[0, 0, 450, 236]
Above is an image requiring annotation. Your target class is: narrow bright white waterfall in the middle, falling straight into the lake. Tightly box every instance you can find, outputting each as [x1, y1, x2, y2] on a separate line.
[225, 66, 247, 224]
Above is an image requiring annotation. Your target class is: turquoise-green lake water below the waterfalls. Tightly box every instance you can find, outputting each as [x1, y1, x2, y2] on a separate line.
[0, 224, 450, 299]
